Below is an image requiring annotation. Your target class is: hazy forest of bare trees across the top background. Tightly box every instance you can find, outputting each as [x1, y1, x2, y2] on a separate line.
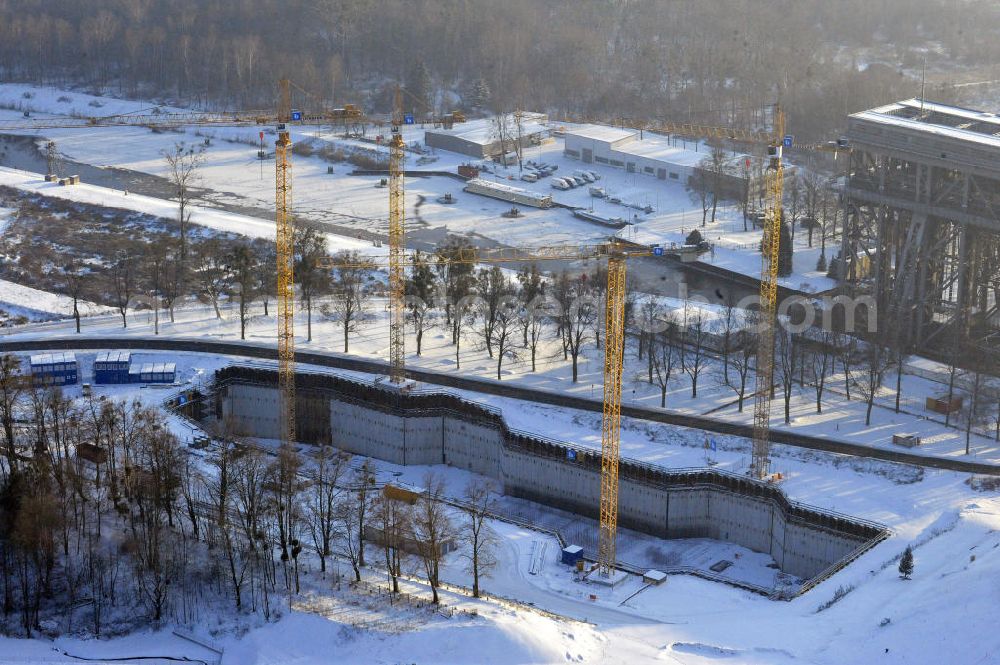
[0, 0, 1000, 137]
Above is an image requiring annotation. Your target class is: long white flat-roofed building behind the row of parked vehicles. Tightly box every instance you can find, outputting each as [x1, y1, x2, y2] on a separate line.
[563, 125, 742, 189]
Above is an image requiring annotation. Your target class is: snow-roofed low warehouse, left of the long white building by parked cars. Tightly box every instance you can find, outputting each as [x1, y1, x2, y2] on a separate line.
[424, 112, 549, 159]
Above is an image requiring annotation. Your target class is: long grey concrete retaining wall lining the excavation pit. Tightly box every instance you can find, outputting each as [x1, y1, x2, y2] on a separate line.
[216, 367, 884, 579]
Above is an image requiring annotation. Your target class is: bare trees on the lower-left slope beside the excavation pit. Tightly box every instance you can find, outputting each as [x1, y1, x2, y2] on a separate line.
[0, 366, 496, 637]
